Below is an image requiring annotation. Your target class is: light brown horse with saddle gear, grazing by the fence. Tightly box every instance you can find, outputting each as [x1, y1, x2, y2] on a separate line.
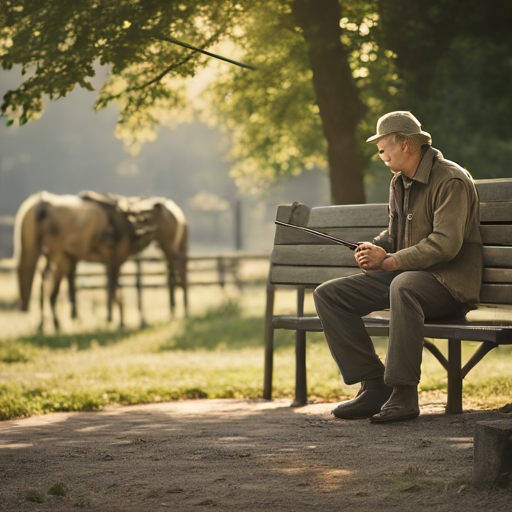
[14, 191, 188, 329]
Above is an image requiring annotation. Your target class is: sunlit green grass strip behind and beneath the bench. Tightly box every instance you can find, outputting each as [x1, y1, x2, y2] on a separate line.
[0, 300, 512, 420]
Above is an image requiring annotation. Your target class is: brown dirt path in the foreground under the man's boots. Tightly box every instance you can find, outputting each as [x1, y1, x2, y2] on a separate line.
[0, 395, 512, 512]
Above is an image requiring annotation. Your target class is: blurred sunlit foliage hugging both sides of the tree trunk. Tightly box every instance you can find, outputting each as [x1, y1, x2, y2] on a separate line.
[209, 1, 398, 190]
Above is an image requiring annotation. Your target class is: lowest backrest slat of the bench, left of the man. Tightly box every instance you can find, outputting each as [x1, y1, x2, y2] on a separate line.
[270, 265, 361, 286]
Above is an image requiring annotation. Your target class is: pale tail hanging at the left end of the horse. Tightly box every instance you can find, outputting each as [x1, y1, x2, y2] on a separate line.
[13, 192, 44, 311]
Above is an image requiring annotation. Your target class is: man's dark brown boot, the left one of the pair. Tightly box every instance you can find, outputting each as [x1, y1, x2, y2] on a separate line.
[331, 377, 393, 420]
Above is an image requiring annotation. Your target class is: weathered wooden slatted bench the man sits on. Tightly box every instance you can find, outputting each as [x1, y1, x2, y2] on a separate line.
[263, 179, 512, 414]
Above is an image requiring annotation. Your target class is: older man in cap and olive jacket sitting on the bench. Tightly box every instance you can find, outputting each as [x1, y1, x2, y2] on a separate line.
[314, 112, 483, 423]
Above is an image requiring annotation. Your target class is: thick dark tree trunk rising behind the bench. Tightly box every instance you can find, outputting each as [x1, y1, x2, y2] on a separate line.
[292, 0, 366, 204]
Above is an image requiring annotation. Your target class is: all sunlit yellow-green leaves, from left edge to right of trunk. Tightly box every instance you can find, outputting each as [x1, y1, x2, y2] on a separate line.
[0, 0, 393, 189]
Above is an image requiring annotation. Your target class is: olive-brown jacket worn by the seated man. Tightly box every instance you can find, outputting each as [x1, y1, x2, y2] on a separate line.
[374, 147, 483, 304]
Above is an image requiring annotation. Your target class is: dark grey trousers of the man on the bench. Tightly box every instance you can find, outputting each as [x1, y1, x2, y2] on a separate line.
[313, 270, 464, 386]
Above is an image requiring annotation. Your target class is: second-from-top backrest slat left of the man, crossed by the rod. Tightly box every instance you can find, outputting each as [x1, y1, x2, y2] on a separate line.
[274, 225, 386, 245]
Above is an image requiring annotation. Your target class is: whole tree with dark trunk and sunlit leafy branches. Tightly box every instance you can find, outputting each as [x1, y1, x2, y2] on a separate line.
[0, 0, 400, 203]
